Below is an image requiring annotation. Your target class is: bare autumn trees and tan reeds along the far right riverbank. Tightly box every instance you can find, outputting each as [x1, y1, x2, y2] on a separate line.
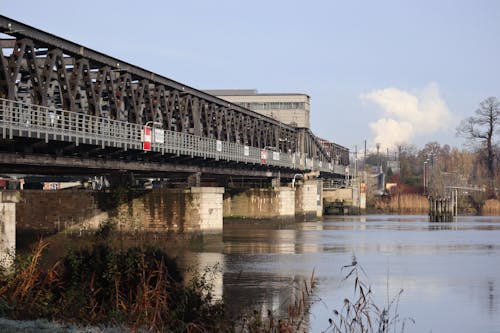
[366, 97, 500, 198]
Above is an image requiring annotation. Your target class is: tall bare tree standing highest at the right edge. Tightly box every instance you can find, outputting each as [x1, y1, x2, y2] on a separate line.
[457, 97, 500, 195]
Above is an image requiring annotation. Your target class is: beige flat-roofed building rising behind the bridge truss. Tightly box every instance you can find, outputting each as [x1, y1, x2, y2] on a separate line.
[204, 89, 311, 128]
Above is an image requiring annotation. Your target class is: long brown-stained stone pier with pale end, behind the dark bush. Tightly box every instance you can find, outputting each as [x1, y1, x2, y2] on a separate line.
[17, 187, 224, 234]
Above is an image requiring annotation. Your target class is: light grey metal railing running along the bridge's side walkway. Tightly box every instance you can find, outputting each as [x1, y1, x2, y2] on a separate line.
[0, 99, 344, 175]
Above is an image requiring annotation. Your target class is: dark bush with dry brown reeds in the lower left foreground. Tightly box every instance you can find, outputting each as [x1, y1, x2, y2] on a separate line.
[0, 242, 225, 332]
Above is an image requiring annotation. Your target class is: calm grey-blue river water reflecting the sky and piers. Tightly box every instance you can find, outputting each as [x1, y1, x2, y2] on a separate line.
[180, 215, 500, 332]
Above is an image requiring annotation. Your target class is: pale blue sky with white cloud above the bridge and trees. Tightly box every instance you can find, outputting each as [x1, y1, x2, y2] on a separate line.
[0, 0, 500, 151]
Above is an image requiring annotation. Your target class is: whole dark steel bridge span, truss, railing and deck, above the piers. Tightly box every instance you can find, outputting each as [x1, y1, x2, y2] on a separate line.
[0, 16, 349, 182]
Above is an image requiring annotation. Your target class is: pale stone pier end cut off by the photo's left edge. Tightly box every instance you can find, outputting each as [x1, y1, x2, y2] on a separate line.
[0, 191, 20, 269]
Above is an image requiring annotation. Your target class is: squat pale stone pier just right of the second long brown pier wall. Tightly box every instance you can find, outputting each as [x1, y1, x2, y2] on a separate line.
[295, 179, 323, 219]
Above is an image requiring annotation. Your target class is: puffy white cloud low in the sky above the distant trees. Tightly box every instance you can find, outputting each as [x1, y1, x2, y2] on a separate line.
[361, 83, 451, 148]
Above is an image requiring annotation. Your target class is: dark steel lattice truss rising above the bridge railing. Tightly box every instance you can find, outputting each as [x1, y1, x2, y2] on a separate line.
[0, 16, 344, 167]
